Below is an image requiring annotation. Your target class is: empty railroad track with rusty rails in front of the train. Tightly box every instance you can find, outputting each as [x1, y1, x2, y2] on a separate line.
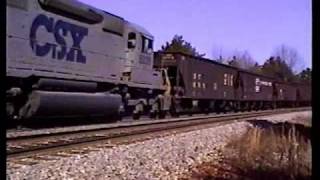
[7, 108, 310, 163]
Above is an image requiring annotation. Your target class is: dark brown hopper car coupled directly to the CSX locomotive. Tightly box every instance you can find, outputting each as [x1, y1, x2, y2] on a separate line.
[155, 53, 237, 113]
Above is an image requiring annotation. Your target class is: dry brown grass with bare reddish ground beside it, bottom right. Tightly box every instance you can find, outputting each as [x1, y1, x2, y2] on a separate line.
[181, 121, 312, 180]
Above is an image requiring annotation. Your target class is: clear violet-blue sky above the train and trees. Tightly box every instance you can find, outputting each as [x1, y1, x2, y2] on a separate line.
[80, 0, 312, 70]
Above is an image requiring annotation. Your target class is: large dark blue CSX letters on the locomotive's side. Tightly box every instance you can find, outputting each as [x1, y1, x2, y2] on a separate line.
[30, 14, 88, 63]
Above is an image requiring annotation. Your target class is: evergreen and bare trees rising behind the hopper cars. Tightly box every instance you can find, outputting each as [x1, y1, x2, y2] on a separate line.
[160, 35, 312, 83]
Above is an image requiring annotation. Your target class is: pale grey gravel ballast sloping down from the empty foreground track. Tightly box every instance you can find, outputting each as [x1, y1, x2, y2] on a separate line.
[7, 111, 311, 180]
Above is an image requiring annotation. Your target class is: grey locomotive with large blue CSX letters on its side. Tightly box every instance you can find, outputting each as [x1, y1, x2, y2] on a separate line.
[6, 0, 168, 120]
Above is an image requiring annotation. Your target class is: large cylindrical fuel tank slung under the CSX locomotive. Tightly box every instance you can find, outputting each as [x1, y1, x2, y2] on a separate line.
[19, 90, 121, 119]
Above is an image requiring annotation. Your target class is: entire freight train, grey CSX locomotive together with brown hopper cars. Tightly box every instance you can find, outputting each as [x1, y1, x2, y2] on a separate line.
[6, 0, 311, 121]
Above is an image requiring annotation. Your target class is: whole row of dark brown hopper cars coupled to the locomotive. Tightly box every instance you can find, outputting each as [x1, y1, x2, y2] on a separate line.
[154, 52, 311, 114]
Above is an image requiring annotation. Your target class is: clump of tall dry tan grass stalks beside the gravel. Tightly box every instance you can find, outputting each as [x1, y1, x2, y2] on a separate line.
[228, 125, 312, 180]
